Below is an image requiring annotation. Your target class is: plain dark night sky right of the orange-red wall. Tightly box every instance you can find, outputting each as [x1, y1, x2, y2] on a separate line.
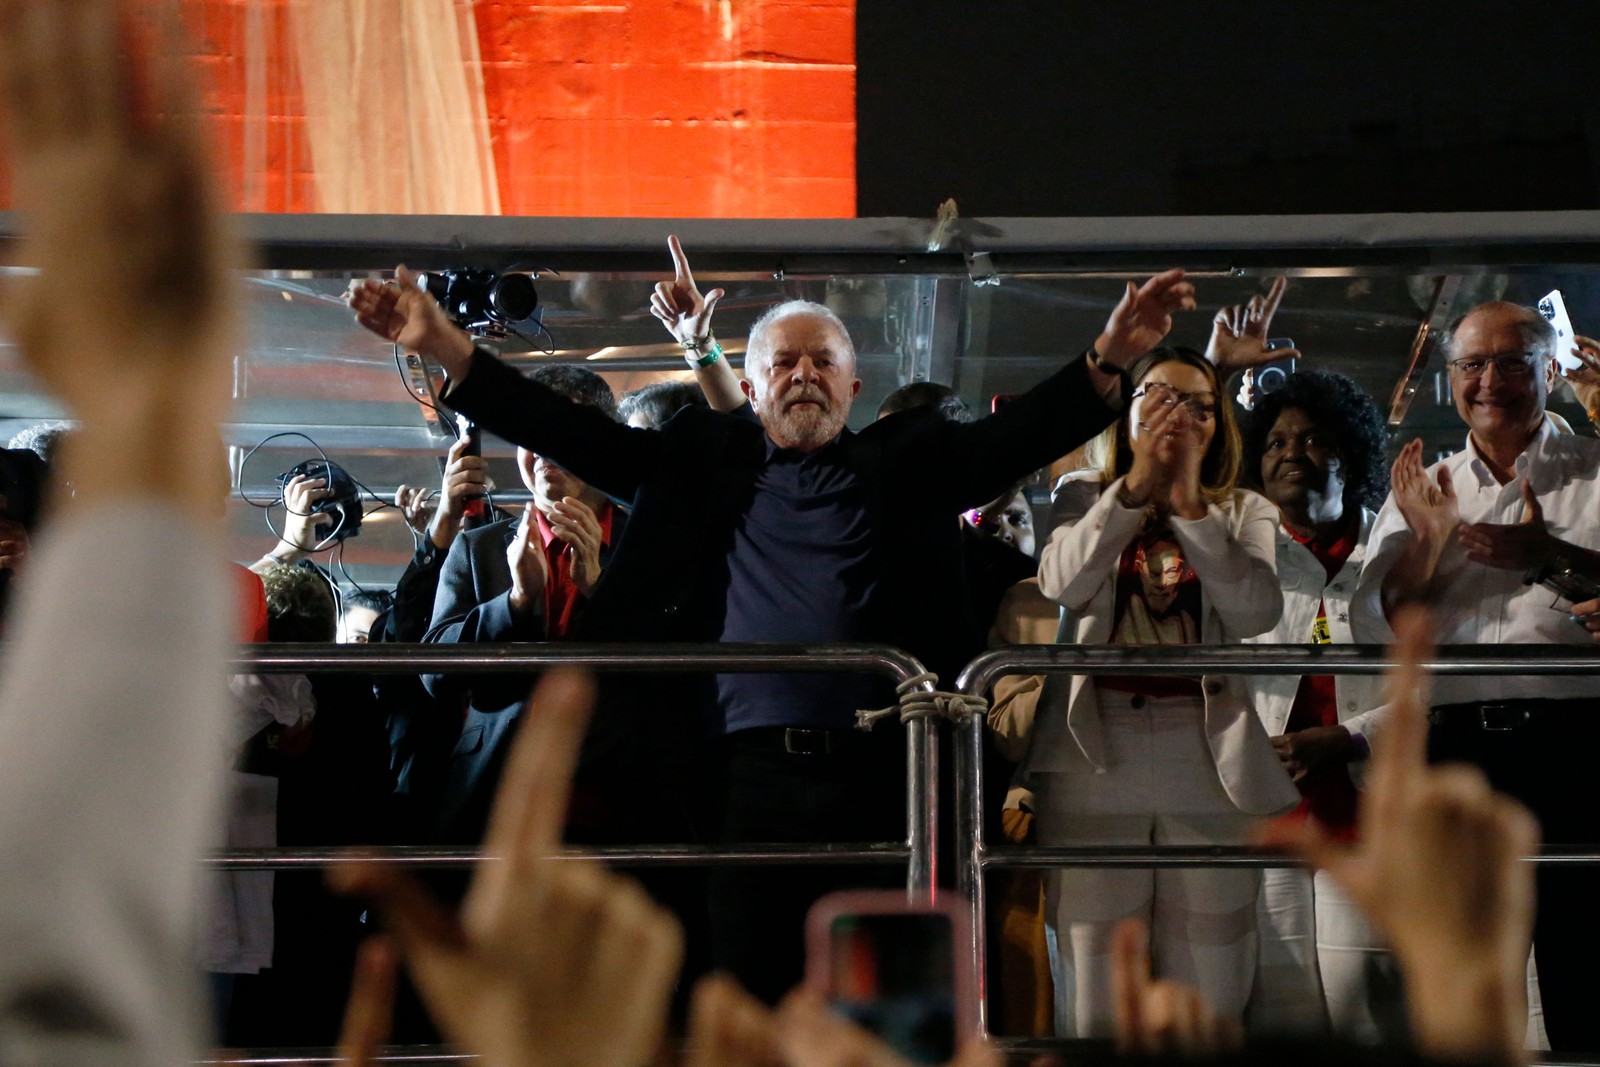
[856, 0, 1600, 216]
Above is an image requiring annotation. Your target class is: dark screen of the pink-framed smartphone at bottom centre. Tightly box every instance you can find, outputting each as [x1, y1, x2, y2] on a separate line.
[827, 912, 957, 1064]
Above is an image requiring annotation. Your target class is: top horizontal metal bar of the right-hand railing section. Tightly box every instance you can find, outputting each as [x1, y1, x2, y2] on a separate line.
[955, 645, 1600, 693]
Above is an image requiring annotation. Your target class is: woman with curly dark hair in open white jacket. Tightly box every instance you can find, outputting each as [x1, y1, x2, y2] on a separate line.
[1242, 371, 1402, 1041]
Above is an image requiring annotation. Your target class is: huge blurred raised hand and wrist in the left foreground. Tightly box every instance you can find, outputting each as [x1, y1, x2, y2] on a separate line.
[0, 0, 243, 517]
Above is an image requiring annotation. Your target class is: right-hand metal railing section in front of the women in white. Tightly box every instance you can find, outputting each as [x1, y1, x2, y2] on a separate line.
[954, 645, 1600, 1037]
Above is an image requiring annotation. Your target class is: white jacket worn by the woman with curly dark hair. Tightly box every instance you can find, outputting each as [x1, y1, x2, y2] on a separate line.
[1245, 509, 1389, 755]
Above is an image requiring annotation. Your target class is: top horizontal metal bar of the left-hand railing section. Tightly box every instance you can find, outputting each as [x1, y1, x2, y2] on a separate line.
[243, 641, 923, 681]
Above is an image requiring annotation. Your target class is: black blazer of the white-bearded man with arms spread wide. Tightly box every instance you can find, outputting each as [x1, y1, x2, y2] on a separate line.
[446, 349, 1128, 683]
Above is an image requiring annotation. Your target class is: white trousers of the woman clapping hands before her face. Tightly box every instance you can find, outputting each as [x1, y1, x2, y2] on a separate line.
[1034, 689, 1261, 1037]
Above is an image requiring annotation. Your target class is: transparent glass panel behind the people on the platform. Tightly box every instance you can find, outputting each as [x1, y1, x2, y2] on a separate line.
[0, 264, 1600, 587]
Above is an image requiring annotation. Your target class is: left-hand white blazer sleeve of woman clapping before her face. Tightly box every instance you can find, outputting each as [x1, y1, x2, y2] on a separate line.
[1038, 478, 1144, 611]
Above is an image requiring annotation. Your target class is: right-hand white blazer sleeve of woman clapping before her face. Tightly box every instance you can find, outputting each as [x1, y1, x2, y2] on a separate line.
[1171, 491, 1283, 638]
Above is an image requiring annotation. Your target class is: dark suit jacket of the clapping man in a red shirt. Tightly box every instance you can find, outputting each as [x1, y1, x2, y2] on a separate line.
[422, 507, 627, 840]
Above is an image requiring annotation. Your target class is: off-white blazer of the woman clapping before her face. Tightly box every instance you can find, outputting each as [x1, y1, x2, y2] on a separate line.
[1026, 470, 1299, 814]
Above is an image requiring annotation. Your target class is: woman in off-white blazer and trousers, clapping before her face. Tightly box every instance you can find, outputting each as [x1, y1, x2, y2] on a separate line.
[1026, 347, 1298, 1037]
